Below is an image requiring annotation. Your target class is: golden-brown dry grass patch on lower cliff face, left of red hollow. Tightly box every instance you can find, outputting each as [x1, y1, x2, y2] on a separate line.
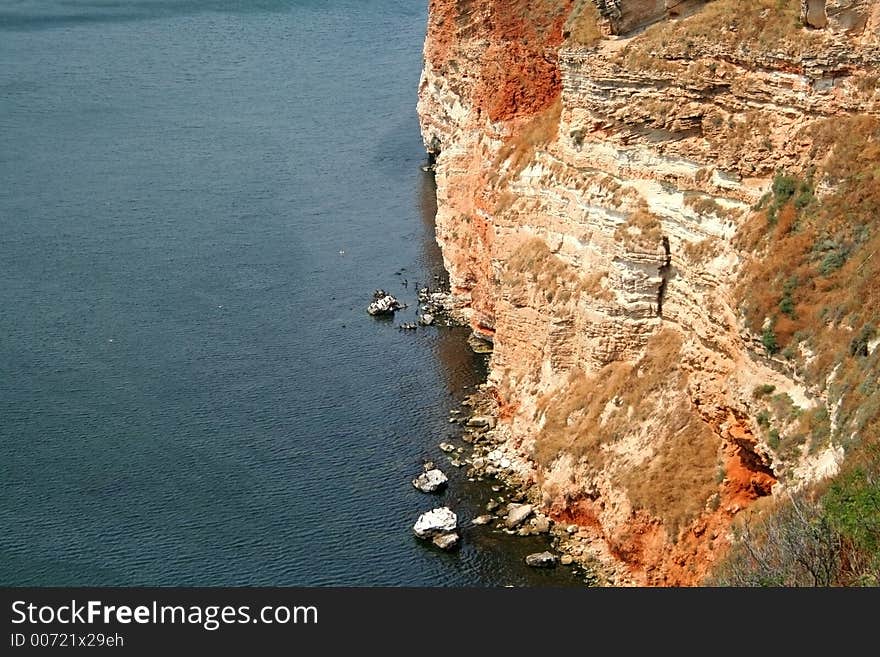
[534, 329, 720, 535]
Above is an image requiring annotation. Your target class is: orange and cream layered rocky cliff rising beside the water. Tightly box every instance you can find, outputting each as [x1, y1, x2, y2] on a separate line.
[418, 0, 880, 585]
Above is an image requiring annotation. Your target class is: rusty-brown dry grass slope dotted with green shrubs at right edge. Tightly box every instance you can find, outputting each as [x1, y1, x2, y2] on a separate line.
[736, 116, 880, 466]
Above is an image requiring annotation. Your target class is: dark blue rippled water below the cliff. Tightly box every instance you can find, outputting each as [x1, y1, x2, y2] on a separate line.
[0, 0, 577, 586]
